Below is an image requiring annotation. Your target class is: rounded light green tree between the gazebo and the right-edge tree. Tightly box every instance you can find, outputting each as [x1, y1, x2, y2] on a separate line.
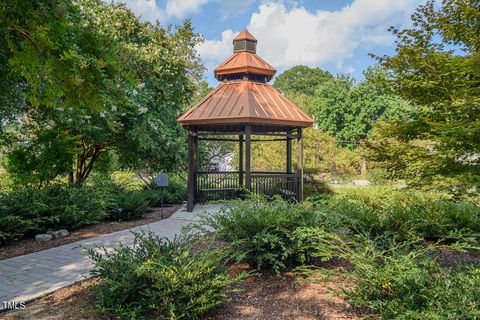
[309, 67, 408, 148]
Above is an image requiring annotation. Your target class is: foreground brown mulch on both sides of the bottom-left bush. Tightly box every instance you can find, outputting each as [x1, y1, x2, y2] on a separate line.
[0, 265, 360, 320]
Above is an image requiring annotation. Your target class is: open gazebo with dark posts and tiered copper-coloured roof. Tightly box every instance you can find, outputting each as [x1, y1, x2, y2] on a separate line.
[178, 29, 313, 211]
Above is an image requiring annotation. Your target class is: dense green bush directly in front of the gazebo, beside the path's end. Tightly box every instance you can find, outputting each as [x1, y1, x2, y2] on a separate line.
[197, 198, 331, 274]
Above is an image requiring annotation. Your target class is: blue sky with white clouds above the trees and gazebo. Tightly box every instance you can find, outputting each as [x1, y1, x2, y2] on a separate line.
[113, 0, 425, 87]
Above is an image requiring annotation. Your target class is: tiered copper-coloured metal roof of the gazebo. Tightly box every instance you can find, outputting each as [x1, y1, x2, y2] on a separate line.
[178, 29, 313, 127]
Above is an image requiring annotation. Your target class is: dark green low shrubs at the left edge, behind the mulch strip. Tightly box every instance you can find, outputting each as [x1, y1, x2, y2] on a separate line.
[0, 185, 115, 243]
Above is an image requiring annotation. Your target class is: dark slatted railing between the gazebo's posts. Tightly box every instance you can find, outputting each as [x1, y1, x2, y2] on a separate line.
[195, 171, 300, 203]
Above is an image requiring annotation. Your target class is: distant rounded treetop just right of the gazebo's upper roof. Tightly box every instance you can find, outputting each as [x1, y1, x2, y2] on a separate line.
[273, 66, 333, 96]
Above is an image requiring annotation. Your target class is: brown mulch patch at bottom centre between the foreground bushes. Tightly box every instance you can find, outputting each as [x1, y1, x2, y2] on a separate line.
[204, 265, 363, 320]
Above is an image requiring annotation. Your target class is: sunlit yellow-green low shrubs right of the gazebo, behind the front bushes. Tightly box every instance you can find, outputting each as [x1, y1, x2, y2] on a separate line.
[314, 187, 480, 241]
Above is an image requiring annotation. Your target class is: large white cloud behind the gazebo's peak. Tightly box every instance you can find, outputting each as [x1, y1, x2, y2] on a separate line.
[199, 0, 423, 68]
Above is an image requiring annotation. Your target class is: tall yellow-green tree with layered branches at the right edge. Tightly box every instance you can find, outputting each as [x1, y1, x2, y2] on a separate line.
[368, 0, 480, 183]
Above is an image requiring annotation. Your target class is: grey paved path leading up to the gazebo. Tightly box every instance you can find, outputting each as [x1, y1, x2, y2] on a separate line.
[0, 204, 222, 310]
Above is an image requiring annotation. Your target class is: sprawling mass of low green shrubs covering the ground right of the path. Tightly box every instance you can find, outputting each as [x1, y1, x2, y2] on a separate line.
[196, 187, 480, 319]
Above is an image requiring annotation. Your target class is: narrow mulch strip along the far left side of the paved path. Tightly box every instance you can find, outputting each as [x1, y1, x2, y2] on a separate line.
[0, 204, 181, 260]
